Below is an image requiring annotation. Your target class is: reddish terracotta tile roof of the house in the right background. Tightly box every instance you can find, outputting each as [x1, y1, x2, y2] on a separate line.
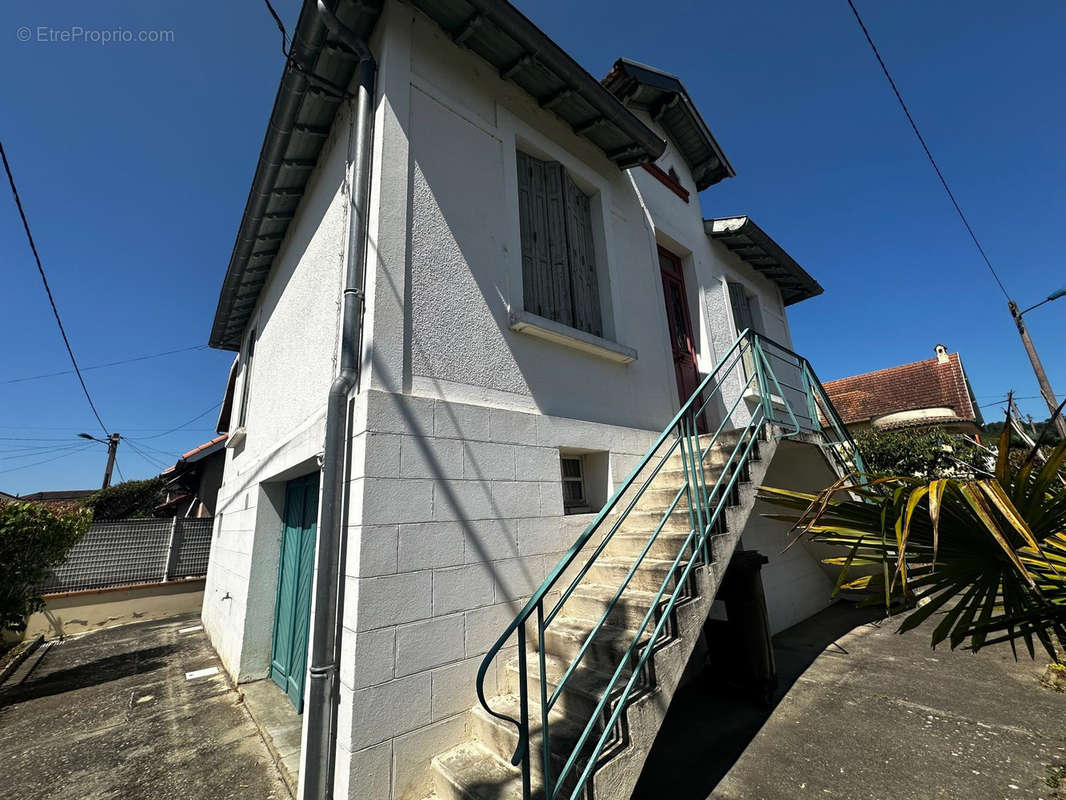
[825, 353, 981, 425]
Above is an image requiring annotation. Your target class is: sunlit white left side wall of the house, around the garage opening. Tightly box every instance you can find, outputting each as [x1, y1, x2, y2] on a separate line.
[203, 93, 349, 681]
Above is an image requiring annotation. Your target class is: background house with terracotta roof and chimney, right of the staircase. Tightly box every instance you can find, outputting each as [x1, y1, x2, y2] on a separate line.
[825, 345, 984, 437]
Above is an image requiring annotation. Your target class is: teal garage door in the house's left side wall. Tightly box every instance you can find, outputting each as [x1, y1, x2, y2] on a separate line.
[270, 473, 319, 711]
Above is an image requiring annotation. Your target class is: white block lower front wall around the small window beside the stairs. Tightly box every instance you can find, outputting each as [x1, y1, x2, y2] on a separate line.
[336, 390, 658, 800]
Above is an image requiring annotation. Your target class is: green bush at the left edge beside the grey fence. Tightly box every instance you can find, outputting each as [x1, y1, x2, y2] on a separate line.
[0, 501, 92, 630]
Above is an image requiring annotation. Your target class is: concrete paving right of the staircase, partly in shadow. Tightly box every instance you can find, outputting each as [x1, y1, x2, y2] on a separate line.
[633, 604, 1066, 800]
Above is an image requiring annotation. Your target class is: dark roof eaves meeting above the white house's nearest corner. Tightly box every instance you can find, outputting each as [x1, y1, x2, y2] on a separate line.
[208, 0, 666, 351]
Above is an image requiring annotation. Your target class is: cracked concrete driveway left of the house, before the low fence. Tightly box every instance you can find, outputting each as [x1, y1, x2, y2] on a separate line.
[0, 617, 289, 800]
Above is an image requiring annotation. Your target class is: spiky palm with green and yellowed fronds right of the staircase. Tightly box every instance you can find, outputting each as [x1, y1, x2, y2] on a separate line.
[761, 429, 1066, 661]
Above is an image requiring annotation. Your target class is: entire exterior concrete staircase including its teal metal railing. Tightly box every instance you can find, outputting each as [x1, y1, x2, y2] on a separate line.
[415, 331, 865, 800]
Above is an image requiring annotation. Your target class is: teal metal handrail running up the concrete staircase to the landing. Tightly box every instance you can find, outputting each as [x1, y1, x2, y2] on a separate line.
[477, 331, 861, 800]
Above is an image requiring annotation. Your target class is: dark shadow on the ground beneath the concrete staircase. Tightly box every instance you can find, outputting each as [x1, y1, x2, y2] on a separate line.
[632, 603, 884, 800]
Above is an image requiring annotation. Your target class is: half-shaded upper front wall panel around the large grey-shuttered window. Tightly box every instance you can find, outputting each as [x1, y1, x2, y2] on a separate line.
[398, 83, 675, 430]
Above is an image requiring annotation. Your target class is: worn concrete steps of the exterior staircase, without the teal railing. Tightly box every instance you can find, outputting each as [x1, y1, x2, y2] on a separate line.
[432, 425, 777, 800]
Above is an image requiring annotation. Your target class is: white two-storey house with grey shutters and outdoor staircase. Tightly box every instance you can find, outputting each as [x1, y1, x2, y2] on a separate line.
[203, 0, 846, 800]
